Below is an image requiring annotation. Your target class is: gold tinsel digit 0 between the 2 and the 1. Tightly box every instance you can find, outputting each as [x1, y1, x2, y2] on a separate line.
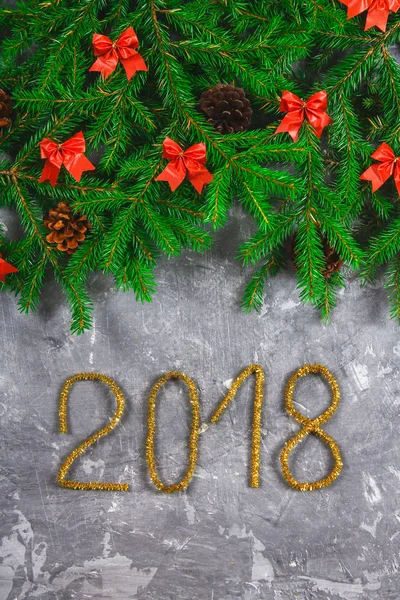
[146, 371, 200, 494]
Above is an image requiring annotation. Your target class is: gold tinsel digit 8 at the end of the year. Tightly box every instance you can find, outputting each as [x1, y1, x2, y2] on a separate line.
[281, 363, 343, 492]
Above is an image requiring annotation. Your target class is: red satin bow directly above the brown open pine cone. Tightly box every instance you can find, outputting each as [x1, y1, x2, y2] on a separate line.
[39, 131, 96, 187]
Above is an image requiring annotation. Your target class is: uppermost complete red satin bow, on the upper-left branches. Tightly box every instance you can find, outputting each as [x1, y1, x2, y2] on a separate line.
[89, 27, 148, 79]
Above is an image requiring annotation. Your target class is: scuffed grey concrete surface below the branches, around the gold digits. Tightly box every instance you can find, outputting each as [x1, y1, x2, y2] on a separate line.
[0, 207, 400, 600]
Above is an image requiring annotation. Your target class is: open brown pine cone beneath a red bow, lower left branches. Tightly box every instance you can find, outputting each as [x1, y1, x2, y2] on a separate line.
[43, 202, 90, 254]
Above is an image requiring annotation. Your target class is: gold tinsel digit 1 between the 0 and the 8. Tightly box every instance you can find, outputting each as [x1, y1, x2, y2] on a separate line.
[211, 365, 264, 487]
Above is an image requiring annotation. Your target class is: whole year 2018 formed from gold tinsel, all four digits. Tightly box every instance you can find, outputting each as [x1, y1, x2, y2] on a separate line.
[57, 363, 343, 494]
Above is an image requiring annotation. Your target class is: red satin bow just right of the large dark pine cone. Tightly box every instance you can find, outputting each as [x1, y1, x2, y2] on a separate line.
[275, 90, 333, 142]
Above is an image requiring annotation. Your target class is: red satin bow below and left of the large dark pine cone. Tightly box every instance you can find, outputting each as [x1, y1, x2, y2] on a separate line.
[156, 137, 213, 194]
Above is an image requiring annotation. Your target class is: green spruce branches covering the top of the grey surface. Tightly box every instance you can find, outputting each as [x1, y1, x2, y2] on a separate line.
[0, 0, 400, 333]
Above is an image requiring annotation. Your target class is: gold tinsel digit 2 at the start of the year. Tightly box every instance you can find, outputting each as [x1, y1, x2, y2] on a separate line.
[57, 373, 129, 492]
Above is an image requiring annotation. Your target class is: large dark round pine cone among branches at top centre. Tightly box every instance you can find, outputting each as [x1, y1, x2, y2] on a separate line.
[200, 83, 253, 133]
